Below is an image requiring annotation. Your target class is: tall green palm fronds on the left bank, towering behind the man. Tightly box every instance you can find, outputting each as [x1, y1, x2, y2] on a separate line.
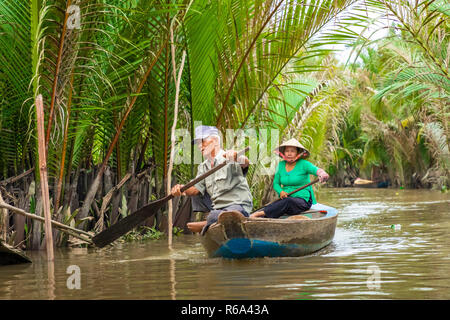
[0, 0, 362, 242]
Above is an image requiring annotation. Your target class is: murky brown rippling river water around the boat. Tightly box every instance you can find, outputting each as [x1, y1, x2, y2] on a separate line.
[0, 189, 450, 300]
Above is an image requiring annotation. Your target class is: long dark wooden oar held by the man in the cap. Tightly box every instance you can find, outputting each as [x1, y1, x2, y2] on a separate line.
[92, 147, 250, 248]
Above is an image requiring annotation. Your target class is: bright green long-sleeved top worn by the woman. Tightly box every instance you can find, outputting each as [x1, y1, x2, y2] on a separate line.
[273, 159, 319, 204]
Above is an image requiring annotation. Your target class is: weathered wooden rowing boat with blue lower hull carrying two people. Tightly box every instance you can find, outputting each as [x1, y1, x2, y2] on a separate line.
[202, 204, 338, 259]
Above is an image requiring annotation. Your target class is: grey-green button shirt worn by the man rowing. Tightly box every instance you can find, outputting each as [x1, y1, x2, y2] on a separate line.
[195, 149, 253, 213]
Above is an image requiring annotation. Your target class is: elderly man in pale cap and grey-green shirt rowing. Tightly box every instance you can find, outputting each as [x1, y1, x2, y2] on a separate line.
[171, 126, 253, 234]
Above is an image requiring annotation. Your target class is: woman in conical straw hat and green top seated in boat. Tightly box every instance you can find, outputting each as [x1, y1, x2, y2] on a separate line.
[250, 139, 329, 218]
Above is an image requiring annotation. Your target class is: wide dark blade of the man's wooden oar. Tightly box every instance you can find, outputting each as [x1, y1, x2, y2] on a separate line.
[92, 197, 168, 248]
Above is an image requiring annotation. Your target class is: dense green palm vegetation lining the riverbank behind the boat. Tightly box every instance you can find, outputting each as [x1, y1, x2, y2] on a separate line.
[0, 0, 450, 249]
